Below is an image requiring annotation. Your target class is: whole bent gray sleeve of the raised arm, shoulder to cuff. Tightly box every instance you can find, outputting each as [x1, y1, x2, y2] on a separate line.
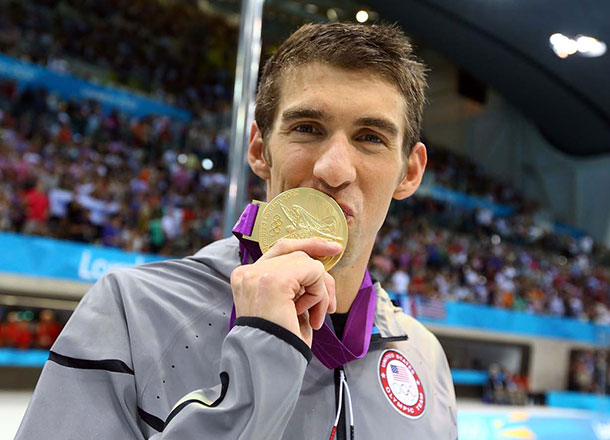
[16, 274, 311, 440]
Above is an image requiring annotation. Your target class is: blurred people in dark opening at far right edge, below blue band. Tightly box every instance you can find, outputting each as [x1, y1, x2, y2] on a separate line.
[568, 349, 610, 394]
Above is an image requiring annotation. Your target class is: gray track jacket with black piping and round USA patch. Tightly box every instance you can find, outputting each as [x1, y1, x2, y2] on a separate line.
[16, 238, 457, 440]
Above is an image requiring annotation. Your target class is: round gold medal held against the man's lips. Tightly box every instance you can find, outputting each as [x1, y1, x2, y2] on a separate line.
[244, 188, 347, 271]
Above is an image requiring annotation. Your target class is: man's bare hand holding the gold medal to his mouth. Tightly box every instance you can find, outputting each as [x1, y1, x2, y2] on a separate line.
[231, 238, 341, 347]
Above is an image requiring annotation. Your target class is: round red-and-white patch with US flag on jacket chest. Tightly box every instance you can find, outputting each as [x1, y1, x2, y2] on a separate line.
[377, 350, 426, 419]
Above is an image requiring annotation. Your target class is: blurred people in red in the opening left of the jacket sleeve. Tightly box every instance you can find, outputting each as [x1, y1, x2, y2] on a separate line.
[0, 308, 63, 350]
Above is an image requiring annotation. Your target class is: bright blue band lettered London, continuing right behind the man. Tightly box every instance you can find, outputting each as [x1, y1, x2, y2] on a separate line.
[0, 232, 610, 346]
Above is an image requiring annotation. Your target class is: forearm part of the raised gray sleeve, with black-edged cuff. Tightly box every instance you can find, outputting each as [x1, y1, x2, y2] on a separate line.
[153, 318, 311, 439]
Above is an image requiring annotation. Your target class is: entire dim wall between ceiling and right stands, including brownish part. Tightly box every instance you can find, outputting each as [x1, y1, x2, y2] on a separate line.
[424, 83, 610, 246]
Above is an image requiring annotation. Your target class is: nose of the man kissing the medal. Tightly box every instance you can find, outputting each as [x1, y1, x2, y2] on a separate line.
[313, 134, 356, 188]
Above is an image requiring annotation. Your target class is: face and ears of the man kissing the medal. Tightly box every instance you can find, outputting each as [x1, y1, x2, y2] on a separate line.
[249, 63, 425, 267]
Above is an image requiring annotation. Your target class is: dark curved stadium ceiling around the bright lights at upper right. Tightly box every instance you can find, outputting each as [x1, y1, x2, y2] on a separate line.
[374, 0, 610, 156]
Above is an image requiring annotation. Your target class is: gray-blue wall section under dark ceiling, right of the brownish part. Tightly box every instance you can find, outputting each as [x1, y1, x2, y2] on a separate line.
[465, 95, 610, 248]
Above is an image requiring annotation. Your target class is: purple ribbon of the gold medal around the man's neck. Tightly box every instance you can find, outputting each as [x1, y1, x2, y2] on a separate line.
[230, 203, 377, 369]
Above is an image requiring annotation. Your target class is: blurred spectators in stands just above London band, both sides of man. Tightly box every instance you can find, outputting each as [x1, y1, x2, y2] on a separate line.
[0, 76, 610, 325]
